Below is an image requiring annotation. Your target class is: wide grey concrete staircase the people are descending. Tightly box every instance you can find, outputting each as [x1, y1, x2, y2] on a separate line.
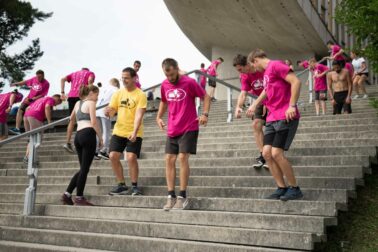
[0, 85, 378, 252]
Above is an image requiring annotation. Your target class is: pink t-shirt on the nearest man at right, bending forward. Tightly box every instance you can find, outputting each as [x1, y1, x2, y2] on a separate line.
[264, 60, 300, 122]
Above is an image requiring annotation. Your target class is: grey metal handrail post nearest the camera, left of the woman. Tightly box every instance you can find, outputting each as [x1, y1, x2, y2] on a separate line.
[23, 133, 41, 216]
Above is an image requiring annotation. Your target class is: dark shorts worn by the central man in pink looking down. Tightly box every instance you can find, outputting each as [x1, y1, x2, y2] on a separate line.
[165, 131, 198, 155]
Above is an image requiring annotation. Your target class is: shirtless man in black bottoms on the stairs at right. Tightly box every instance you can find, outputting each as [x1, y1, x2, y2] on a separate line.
[327, 61, 352, 115]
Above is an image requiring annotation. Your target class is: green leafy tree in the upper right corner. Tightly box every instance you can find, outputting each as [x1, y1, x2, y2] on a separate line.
[336, 0, 378, 72]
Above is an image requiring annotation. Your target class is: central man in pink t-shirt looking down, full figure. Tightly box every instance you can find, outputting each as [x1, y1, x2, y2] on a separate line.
[156, 58, 210, 211]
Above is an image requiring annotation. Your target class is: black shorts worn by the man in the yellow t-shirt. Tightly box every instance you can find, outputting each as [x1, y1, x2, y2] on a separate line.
[109, 135, 143, 158]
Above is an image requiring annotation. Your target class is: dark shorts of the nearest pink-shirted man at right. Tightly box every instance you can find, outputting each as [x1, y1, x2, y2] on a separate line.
[264, 119, 299, 151]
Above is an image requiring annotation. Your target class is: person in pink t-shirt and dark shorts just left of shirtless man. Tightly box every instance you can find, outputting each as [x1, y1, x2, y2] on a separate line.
[310, 59, 329, 116]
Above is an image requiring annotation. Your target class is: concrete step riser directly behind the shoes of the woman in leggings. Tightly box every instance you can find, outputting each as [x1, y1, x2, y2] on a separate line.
[0, 183, 355, 203]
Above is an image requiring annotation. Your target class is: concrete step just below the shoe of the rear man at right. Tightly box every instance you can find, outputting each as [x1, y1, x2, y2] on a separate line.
[0, 164, 370, 179]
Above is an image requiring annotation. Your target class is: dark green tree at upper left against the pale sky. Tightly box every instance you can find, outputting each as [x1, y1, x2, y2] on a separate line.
[0, 0, 52, 88]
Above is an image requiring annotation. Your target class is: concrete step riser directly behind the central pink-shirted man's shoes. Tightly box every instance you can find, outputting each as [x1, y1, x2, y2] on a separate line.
[0, 192, 340, 217]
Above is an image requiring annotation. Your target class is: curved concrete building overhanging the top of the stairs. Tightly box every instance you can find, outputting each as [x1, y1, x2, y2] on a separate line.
[164, 0, 374, 99]
